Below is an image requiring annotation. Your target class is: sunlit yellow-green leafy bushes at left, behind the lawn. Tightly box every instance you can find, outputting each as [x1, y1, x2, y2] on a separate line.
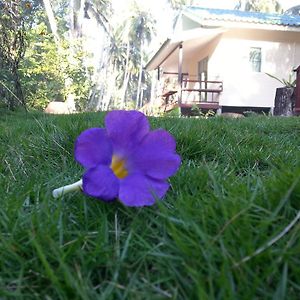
[21, 23, 90, 109]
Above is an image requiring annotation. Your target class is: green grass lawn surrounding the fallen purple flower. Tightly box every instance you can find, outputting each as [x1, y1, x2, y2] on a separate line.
[0, 111, 300, 300]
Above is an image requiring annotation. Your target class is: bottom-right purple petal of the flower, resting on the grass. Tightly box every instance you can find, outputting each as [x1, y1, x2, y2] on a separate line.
[119, 173, 169, 206]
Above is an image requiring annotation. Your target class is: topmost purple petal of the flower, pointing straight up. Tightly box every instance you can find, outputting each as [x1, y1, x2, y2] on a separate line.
[105, 110, 150, 156]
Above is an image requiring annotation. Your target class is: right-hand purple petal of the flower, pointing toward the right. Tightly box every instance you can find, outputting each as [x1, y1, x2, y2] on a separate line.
[129, 129, 181, 180]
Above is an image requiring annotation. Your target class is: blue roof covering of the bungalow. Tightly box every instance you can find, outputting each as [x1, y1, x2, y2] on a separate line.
[183, 6, 300, 27]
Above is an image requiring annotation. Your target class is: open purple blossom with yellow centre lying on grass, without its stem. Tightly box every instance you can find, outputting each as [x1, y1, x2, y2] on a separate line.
[75, 110, 180, 206]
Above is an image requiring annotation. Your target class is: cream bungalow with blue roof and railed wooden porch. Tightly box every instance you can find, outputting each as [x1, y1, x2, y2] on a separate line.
[145, 6, 300, 112]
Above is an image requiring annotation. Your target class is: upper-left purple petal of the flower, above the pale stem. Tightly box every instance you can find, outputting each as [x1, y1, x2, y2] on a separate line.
[74, 128, 112, 168]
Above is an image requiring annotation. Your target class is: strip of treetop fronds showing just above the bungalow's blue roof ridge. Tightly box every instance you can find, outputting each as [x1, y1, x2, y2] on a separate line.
[236, 0, 282, 13]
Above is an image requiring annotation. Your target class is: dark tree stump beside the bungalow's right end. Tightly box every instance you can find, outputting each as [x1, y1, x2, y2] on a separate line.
[274, 87, 295, 116]
